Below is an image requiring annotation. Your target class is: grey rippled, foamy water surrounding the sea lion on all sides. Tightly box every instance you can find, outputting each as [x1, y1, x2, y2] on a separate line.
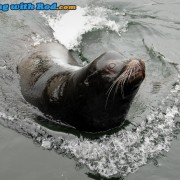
[0, 0, 180, 179]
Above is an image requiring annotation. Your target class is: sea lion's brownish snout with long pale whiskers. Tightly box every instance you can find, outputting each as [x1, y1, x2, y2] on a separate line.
[100, 59, 145, 102]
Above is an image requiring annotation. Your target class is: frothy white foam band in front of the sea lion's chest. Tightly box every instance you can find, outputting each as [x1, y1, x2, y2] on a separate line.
[54, 79, 180, 177]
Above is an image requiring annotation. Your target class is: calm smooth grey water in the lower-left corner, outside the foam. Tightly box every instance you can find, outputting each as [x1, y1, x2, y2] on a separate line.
[0, 127, 87, 180]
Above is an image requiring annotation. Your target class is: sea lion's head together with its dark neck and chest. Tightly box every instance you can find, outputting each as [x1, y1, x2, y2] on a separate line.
[70, 51, 145, 131]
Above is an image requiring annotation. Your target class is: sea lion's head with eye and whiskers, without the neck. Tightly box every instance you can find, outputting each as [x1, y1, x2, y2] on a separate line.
[84, 51, 145, 99]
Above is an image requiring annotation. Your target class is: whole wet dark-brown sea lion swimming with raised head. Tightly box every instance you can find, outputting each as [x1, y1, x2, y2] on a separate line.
[18, 43, 145, 132]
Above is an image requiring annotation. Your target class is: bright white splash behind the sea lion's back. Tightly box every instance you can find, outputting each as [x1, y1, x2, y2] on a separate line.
[41, 7, 128, 50]
